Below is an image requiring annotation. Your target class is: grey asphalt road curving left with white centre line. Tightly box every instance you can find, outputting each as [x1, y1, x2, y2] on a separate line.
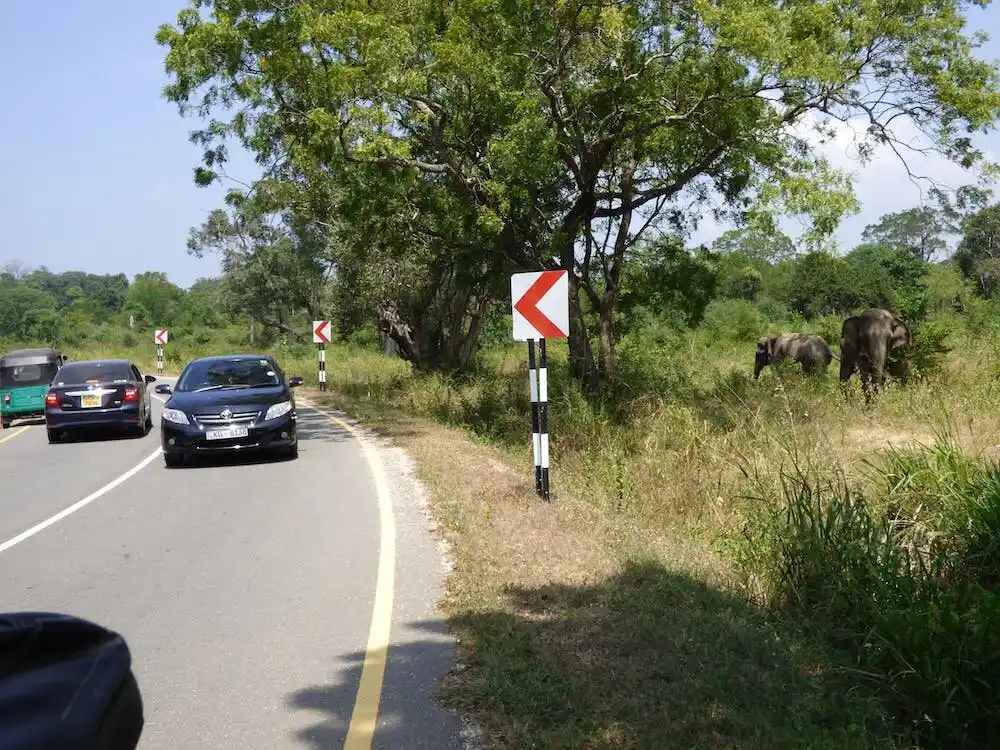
[0, 382, 463, 750]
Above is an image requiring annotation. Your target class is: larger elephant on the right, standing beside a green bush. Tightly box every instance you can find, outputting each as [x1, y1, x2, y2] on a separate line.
[840, 307, 913, 401]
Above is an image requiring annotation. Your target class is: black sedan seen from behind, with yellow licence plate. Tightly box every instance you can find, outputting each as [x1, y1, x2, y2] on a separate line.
[45, 359, 156, 443]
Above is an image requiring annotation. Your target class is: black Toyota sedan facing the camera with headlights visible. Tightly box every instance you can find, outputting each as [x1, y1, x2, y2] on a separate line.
[156, 354, 302, 467]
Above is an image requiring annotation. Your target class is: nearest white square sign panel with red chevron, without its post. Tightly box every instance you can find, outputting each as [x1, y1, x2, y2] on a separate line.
[510, 271, 569, 341]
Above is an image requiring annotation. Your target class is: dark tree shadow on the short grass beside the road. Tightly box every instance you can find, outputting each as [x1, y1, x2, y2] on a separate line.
[440, 562, 893, 750]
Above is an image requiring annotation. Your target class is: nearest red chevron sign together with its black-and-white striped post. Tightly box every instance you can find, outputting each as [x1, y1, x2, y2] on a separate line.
[510, 271, 569, 500]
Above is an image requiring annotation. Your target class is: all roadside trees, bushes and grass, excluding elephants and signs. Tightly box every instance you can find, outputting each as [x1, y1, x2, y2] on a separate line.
[9, 0, 1000, 750]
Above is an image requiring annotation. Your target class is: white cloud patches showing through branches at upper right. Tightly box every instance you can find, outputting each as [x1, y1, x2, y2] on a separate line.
[690, 110, 1000, 252]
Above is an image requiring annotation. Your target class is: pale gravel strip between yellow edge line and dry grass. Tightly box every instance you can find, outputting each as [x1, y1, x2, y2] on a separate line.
[319, 414, 485, 750]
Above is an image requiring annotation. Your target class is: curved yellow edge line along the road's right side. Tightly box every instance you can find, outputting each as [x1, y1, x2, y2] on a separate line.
[299, 401, 396, 750]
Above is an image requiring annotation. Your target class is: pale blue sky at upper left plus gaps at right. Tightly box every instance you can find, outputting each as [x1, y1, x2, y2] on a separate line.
[0, 0, 1000, 287]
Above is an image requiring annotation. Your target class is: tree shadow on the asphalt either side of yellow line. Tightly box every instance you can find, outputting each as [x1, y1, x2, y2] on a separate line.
[288, 620, 463, 750]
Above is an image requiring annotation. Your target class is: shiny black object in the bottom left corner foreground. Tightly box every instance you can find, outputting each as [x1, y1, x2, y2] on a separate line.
[0, 612, 144, 750]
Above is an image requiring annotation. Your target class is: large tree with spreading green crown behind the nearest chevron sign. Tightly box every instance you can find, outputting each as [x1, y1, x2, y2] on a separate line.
[158, 0, 1000, 390]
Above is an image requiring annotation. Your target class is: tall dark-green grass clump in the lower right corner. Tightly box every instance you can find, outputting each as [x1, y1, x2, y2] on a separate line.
[733, 435, 1000, 748]
